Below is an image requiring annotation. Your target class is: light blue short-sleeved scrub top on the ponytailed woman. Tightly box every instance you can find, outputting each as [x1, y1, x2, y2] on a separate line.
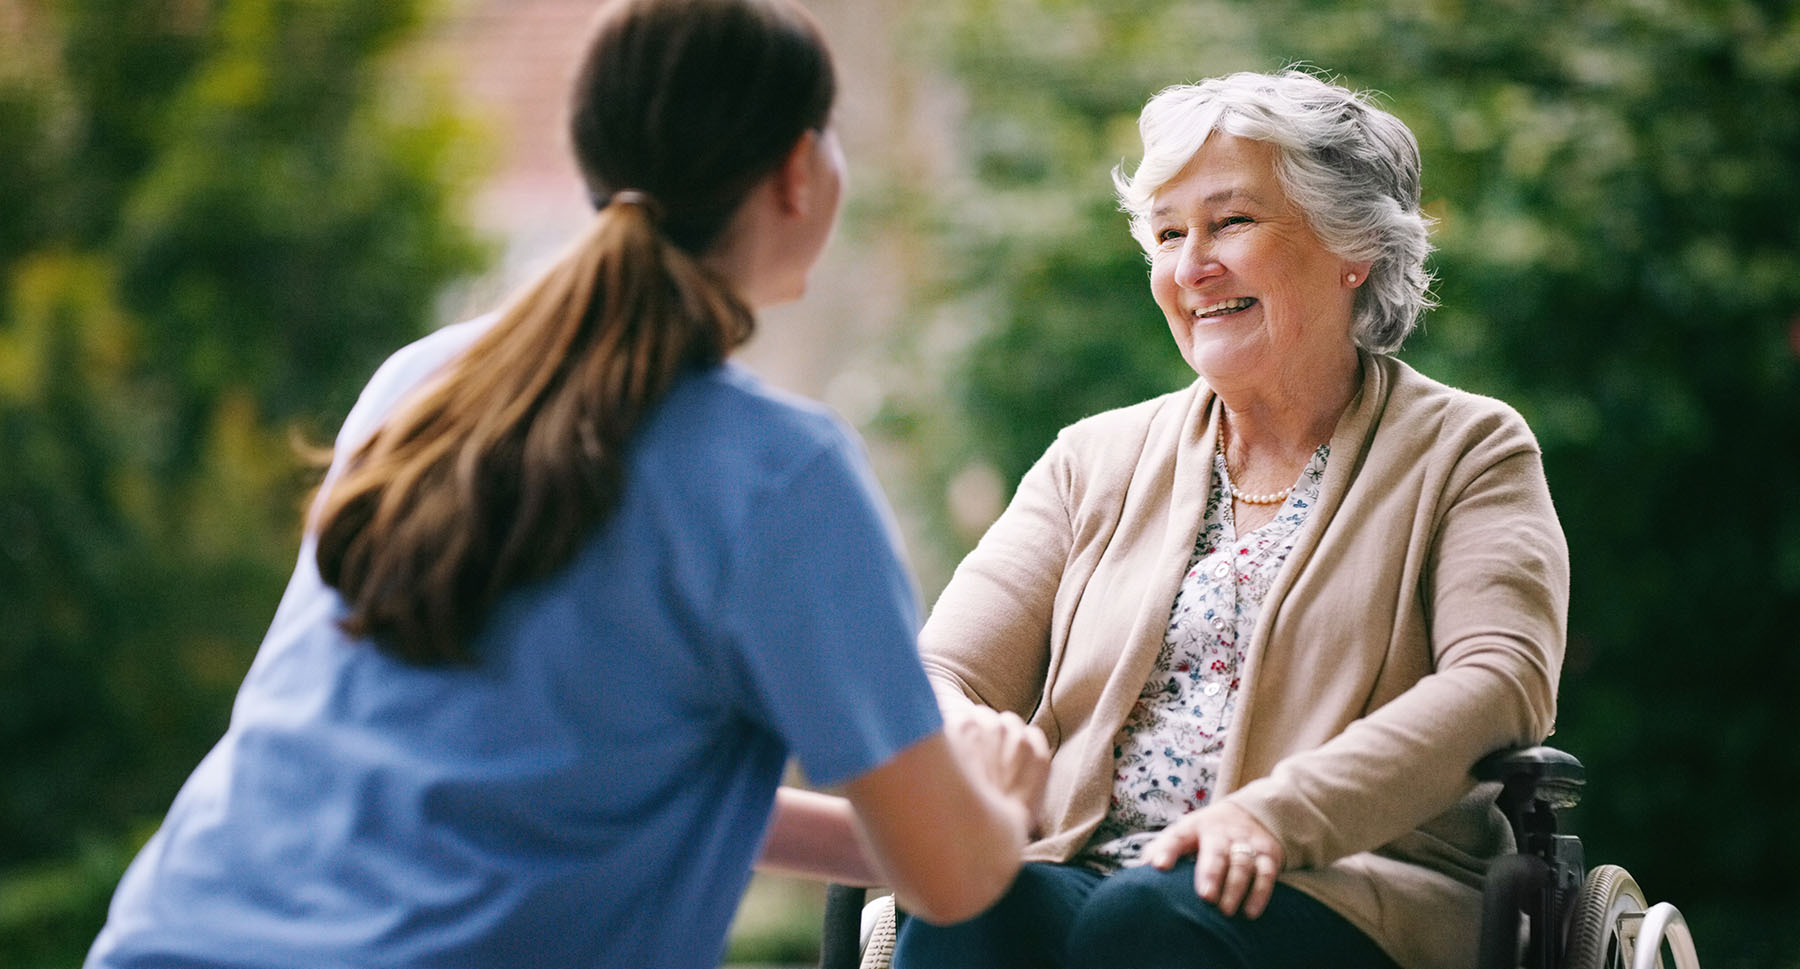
[86, 321, 940, 969]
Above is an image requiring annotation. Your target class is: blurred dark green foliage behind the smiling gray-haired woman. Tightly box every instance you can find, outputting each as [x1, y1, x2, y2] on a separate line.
[887, 0, 1800, 967]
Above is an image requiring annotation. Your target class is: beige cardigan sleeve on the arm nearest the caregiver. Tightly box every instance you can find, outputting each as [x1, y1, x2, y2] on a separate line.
[920, 438, 1073, 719]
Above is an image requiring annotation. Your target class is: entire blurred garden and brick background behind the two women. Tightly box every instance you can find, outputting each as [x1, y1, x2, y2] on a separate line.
[0, 0, 1800, 969]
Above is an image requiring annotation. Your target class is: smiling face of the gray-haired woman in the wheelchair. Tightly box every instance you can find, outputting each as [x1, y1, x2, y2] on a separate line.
[1148, 131, 1368, 389]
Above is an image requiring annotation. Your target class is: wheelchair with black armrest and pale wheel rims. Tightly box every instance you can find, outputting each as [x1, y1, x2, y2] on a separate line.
[819, 747, 1699, 969]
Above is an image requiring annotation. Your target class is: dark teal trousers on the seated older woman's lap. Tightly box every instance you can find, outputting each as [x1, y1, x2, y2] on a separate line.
[895, 861, 1395, 969]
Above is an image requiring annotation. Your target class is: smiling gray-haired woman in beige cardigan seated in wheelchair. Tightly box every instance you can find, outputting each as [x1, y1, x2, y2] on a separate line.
[896, 72, 1568, 969]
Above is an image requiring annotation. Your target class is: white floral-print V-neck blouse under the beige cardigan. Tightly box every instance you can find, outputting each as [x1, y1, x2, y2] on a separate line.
[1075, 445, 1330, 872]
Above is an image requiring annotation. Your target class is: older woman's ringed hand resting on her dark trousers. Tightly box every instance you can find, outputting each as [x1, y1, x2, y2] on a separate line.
[1143, 801, 1283, 919]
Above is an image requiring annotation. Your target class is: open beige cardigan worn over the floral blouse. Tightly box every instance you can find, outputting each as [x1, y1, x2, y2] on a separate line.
[922, 355, 1570, 969]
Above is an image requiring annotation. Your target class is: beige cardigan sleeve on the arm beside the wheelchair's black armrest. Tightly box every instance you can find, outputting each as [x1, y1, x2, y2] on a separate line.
[1229, 412, 1570, 868]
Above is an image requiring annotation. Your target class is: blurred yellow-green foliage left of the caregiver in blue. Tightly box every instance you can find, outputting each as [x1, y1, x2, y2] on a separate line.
[0, 0, 482, 965]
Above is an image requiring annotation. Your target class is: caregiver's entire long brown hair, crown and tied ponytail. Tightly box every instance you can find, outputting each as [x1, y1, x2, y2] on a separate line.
[313, 0, 833, 663]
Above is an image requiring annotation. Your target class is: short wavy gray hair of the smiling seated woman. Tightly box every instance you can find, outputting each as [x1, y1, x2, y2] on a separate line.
[1112, 70, 1435, 353]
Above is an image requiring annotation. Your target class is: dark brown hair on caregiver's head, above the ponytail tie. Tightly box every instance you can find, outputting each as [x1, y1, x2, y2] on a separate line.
[571, 0, 837, 254]
